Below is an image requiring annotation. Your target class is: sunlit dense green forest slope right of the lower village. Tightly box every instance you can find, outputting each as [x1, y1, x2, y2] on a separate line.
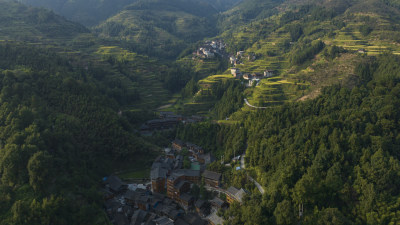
[177, 55, 400, 224]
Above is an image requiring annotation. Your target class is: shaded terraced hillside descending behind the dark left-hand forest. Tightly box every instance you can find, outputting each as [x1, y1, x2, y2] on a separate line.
[0, 1, 181, 111]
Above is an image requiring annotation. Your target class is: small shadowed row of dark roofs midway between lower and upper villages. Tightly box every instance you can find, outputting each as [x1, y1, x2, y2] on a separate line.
[140, 112, 204, 132]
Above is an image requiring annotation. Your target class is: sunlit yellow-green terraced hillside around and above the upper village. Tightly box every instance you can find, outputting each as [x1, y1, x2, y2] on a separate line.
[183, 0, 400, 114]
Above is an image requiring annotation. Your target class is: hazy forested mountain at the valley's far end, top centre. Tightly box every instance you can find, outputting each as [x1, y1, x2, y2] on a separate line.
[94, 0, 217, 57]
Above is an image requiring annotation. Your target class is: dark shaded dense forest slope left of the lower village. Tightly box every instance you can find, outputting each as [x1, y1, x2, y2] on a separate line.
[0, 44, 152, 224]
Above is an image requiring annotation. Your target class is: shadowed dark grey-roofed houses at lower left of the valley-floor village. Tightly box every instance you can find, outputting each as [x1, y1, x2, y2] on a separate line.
[103, 175, 208, 225]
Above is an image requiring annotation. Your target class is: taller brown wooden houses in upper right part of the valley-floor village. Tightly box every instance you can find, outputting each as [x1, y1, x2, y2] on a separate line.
[150, 140, 246, 224]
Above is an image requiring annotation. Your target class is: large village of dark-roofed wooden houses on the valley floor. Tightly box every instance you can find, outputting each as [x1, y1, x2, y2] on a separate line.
[103, 140, 247, 225]
